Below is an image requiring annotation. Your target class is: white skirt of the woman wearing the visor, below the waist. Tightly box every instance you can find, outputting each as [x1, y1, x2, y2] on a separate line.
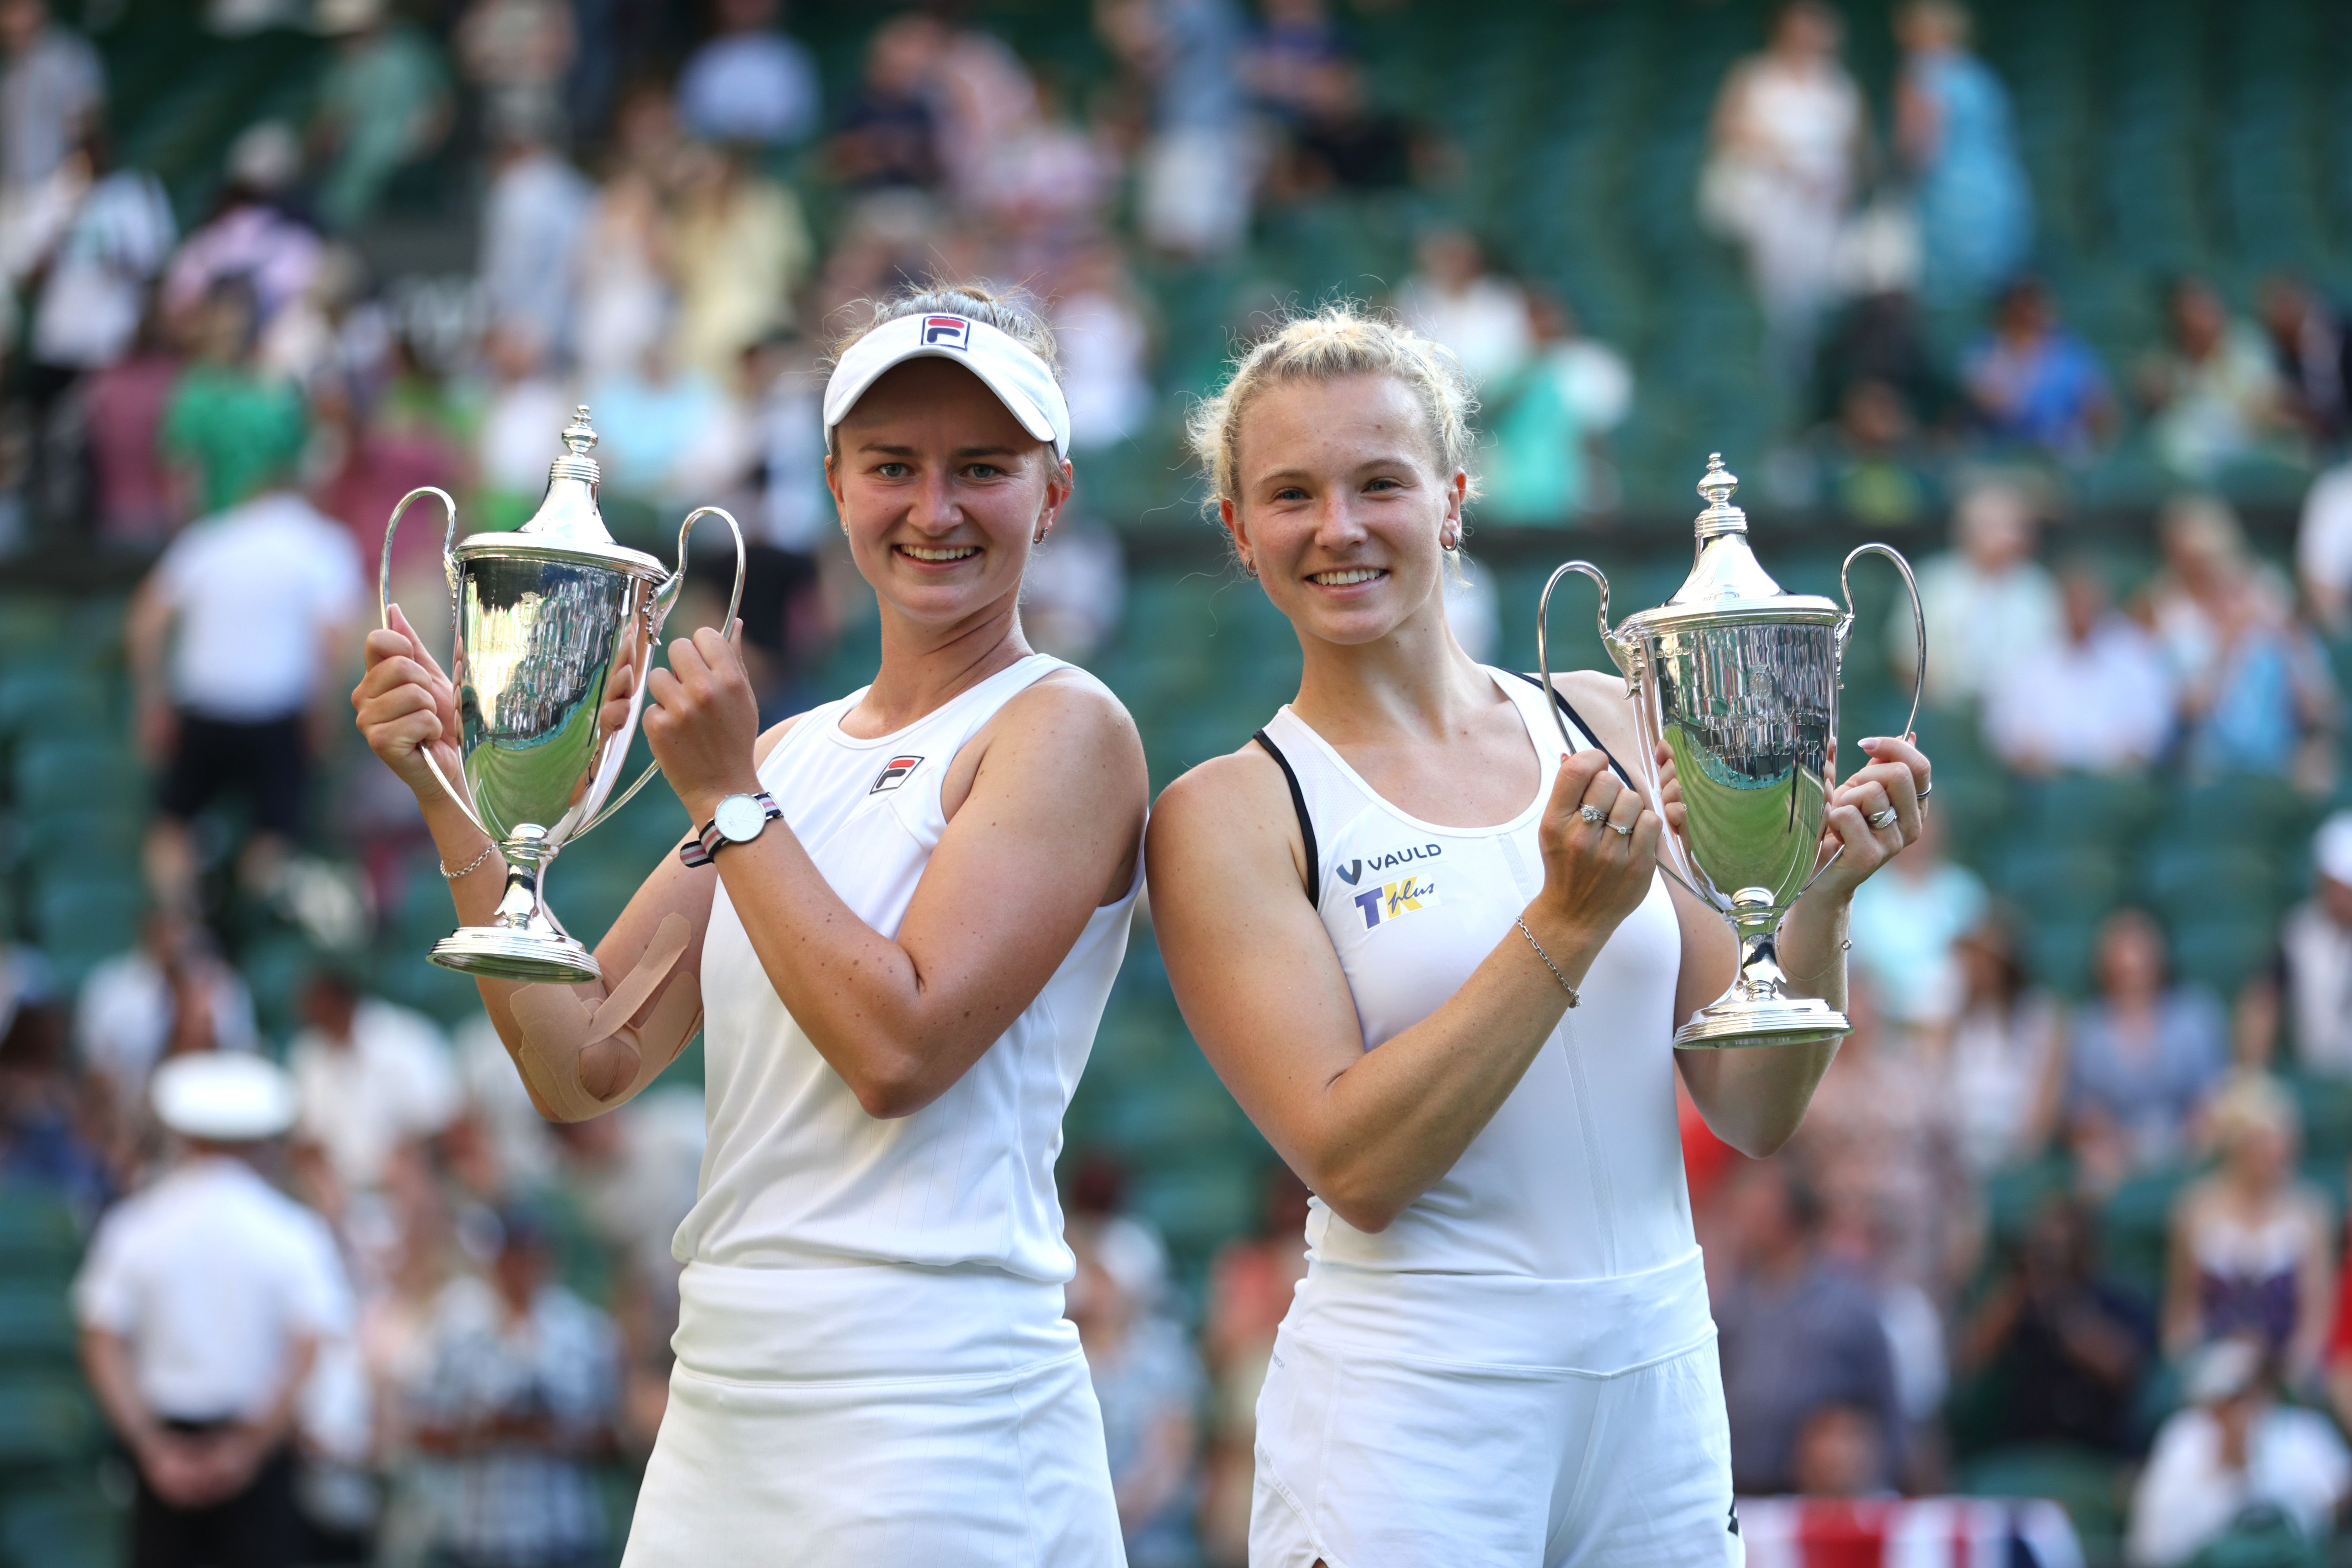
[621, 1262, 1127, 1568]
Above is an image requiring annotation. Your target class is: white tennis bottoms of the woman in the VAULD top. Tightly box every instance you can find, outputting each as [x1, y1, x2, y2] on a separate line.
[1249, 1250, 1745, 1568]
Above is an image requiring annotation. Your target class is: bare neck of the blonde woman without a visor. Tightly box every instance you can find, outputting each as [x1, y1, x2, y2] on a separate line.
[1291, 597, 1496, 748]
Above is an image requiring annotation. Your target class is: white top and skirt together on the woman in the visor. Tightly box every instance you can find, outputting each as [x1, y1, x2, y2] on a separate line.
[623, 656, 1143, 1568]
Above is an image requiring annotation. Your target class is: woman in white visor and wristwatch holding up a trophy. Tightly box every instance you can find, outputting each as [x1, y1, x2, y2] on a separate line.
[353, 289, 1148, 1568]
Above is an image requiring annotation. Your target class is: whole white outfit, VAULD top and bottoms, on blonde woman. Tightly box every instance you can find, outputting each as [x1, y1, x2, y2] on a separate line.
[1249, 670, 1745, 1568]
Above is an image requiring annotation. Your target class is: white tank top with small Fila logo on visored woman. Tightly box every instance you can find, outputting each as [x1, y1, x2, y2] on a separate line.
[673, 653, 1143, 1283]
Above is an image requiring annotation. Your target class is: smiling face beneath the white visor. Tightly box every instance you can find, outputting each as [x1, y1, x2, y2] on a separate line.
[826, 360, 1070, 625]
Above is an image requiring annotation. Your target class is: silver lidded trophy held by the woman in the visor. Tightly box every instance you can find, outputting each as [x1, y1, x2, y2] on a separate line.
[376, 407, 743, 985]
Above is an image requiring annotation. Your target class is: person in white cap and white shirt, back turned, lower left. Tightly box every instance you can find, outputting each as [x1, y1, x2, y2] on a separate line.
[73, 1051, 350, 1568]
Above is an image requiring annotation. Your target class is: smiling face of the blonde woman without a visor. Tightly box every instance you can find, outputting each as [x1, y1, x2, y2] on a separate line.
[1218, 374, 1470, 646]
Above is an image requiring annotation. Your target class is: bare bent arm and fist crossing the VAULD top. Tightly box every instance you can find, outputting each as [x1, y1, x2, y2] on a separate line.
[1148, 745, 1658, 1232]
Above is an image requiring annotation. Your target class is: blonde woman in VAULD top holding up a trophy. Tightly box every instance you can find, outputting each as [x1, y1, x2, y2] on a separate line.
[1148, 306, 1929, 1568]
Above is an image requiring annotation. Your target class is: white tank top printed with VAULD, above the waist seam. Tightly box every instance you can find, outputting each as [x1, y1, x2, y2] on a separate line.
[1265, 670, 1698, 1288]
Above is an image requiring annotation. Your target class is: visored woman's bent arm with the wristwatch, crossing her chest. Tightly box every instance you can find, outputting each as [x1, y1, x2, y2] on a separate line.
[644, 628, 1150, 1117]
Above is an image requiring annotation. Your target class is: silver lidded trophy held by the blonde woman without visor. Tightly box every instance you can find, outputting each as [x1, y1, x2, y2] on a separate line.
[1536, 454, 1926, 1046]
